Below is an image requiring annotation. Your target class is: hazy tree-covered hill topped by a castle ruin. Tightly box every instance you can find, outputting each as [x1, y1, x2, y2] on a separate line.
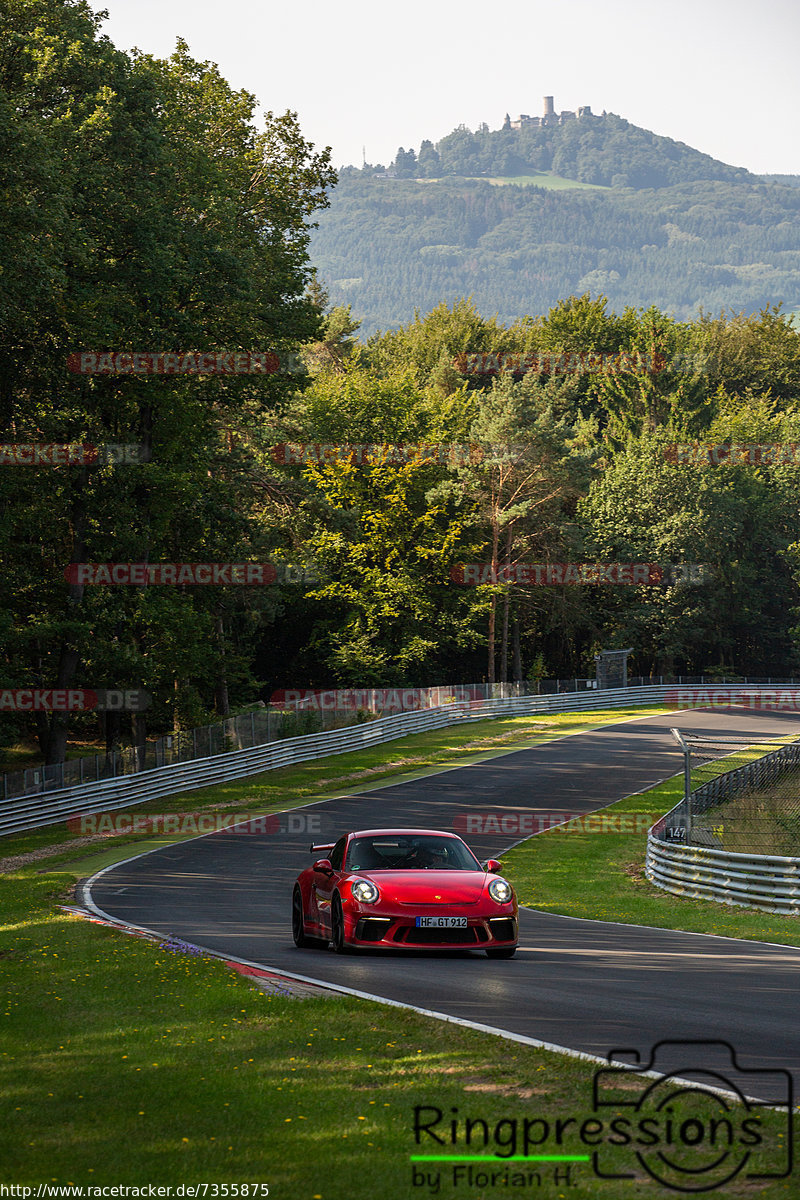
[311, 116, 800, 335]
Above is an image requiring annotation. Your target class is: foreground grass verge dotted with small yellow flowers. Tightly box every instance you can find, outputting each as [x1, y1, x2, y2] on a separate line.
[0, 870, 787, 1200]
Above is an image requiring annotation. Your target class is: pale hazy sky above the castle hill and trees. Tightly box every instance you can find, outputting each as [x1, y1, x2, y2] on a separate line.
[92, 0, 800, 174]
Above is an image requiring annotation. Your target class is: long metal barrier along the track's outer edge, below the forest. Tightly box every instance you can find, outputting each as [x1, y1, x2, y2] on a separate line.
[0, 684, 796, 835]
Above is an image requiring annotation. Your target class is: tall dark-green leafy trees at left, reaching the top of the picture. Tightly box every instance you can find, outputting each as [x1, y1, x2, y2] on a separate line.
[0, 0, 335, 762]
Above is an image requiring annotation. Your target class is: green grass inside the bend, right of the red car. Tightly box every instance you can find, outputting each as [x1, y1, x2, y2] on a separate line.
[503, 746, 800, 946]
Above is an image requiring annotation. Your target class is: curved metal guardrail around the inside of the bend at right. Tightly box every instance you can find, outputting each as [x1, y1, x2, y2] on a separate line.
[645, 729, 800, 916]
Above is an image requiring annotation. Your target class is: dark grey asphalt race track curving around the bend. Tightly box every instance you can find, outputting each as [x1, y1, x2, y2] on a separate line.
[91, 710, 800, 1099]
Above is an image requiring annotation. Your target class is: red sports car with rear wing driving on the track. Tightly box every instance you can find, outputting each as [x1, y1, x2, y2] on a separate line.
[291, 829, 518, 959]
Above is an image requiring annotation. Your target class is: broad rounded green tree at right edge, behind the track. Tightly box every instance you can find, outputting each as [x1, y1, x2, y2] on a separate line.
[578, 432, 798, 676]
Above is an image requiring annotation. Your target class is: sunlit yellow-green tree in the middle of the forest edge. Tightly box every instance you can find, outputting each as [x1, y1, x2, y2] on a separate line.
[266, 364, 475, 686]
